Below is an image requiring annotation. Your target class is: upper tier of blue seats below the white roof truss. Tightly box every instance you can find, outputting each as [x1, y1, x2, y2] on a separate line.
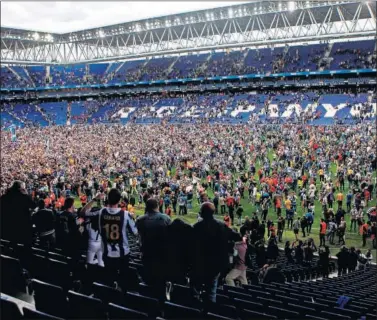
[1, 41, 376, 88]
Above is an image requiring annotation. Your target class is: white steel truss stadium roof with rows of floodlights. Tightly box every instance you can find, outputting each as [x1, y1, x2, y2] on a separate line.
[1, 0, 376, 63]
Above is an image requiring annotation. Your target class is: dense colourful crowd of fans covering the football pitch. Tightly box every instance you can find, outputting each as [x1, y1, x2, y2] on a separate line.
[1, 124, 377, 299]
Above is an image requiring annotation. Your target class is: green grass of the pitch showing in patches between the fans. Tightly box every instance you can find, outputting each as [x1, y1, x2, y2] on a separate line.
[76, 151, 376, 255]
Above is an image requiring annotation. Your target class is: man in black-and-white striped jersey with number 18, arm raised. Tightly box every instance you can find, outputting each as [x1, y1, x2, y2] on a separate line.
[81, 189, 137, 283]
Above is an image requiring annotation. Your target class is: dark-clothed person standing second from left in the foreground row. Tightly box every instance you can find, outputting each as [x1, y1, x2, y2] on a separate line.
[32, 200, 55, 249]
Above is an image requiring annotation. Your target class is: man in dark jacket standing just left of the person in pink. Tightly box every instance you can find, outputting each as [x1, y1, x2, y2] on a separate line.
[192, 202, 240, 303]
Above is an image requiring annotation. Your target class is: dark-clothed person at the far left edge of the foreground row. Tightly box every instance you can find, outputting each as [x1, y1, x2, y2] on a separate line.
[0, 181, 36, 248]
